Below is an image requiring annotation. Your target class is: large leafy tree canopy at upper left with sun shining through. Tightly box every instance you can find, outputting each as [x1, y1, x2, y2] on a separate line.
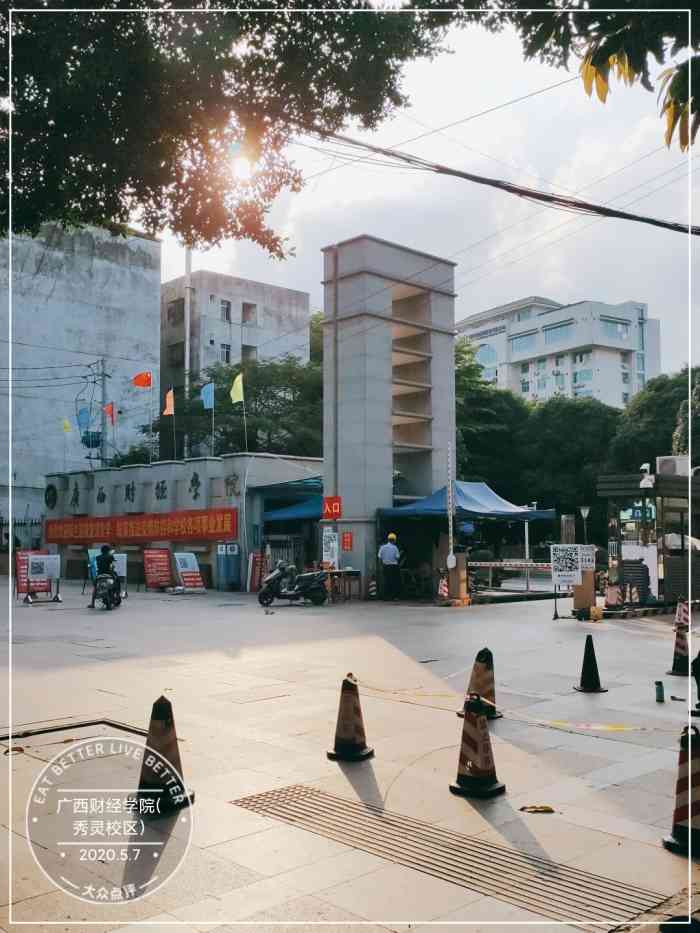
[0, 7, 450, 248]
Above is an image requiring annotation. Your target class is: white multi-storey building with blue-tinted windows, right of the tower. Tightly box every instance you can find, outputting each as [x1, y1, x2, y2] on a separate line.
[457, 296, 660, 408]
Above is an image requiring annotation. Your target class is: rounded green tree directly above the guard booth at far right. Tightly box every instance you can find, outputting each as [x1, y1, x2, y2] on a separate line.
[609, 369, 700, 473]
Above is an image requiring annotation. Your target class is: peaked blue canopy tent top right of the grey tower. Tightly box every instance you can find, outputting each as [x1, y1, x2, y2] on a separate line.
[379, 480, 556, 522]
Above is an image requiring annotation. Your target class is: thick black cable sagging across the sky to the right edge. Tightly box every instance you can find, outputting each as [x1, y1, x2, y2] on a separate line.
[319, 131, 700, 236]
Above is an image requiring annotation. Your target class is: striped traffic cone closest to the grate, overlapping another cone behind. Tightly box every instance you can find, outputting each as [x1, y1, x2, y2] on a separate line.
[450, 693, 506, 797]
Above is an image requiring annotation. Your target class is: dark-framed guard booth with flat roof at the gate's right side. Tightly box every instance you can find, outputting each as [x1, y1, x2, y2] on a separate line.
[597, 457, 700, 603]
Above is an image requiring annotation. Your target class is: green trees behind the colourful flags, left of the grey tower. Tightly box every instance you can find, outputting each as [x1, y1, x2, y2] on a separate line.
[153, 356, 323, 458]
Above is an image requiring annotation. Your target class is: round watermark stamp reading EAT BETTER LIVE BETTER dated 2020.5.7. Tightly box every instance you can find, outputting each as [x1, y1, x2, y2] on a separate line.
[27, 736, 192, 904]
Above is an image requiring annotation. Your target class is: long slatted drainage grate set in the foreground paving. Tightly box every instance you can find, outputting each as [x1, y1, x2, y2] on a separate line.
[231, 784, 667, 927]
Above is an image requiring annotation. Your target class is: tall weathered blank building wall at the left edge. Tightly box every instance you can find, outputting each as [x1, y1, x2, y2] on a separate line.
[0, 224, 160, 519]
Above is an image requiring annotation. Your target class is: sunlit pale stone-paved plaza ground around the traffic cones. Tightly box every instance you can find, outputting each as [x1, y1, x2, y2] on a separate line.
[0, 586, 695, 931]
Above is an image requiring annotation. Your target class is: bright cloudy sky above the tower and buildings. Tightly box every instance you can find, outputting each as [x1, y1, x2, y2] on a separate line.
[163, 20, 700, 372]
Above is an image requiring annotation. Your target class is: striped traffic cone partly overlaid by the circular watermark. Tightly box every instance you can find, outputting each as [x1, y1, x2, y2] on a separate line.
[138, 696, 194, 818]
